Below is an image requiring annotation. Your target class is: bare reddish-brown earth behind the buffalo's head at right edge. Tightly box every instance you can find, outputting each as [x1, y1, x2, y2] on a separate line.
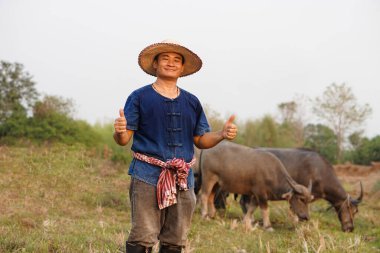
[334, 162, 380, 198]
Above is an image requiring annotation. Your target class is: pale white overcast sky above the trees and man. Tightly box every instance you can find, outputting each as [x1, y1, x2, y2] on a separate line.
[0, 0, 380, 137]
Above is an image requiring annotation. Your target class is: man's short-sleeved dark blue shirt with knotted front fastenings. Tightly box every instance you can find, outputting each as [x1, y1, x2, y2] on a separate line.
[124, 85, 210, 188]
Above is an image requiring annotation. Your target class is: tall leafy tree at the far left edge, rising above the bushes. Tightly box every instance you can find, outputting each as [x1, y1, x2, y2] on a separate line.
[0, 61, 38, 124]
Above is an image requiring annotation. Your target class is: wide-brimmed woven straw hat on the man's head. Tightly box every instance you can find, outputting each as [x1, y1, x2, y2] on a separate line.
[139, 40, 202, 77]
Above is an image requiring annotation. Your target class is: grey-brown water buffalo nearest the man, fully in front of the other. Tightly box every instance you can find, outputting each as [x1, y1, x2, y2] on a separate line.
[198, 141, 313, 230]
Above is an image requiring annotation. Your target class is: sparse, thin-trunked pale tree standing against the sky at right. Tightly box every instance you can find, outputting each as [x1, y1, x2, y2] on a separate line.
[313, 83, 372, 162]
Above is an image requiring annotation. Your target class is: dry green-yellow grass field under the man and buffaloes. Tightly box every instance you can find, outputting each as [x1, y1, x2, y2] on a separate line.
[0, 145, 380, 253]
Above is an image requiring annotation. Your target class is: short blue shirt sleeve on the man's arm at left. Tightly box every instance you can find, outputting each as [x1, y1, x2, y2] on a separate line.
[124, 92, 140, 131]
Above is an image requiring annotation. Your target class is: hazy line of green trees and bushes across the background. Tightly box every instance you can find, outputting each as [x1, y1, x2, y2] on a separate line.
[0, 61, 380, 164]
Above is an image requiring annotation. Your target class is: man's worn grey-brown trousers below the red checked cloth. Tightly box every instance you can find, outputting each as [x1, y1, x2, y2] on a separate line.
[128, 178, 196, 247]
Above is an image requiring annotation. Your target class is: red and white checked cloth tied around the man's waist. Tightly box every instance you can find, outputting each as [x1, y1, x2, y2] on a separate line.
[133, 153, 195, 209]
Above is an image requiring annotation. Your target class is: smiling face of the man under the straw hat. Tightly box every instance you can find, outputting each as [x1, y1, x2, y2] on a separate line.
[153, 53, 184, 78]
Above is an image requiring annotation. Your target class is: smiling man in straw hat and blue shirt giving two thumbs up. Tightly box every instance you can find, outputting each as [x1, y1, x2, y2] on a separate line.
[114, 40, 237, 253]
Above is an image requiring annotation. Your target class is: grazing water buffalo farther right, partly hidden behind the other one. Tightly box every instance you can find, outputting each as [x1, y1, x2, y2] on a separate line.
[238, 148, 363, 232]
